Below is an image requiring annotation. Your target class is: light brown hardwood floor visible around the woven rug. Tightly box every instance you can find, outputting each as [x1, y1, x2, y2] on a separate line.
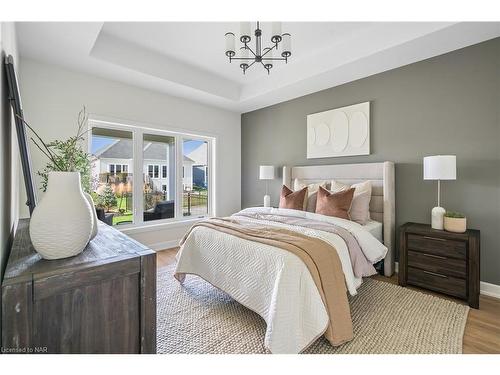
[157, 248, 500, 354]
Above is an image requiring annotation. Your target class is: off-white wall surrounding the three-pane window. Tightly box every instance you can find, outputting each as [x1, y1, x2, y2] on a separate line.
[20, 58, 241, 248]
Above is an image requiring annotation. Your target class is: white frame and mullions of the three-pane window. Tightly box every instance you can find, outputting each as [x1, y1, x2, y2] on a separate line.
[88, 116, 218, 231]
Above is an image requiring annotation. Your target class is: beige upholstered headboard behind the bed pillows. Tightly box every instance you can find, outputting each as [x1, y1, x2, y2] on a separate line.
[283, 161, 396, 276]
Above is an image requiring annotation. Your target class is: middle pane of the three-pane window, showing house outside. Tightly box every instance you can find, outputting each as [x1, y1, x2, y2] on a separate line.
[142, 134, 176, 221]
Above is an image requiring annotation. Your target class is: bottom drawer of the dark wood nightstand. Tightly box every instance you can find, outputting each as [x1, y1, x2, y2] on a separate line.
[408, 267, 467, 298]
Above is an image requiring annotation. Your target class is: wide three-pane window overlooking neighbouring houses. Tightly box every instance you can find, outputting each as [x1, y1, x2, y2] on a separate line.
[89, 120, 215, 226]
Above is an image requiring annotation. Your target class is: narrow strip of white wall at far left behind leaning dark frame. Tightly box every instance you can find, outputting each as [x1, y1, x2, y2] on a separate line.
[0, 22, 19, 336]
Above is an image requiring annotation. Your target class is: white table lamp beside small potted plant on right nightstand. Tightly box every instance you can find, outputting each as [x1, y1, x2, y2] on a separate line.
[424, 155, 457, 230]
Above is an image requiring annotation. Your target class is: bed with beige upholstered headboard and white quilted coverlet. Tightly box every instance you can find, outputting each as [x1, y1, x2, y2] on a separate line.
[175, 162, 395, 353]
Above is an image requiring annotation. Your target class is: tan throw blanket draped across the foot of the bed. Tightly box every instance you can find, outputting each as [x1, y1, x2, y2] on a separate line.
[175, 218, 353, 346]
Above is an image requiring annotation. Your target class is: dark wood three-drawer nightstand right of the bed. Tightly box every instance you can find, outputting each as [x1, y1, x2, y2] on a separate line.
[399, 223, 480, 309]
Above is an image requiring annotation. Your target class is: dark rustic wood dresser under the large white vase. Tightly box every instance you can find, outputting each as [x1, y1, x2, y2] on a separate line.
[2, 219, 156, 353]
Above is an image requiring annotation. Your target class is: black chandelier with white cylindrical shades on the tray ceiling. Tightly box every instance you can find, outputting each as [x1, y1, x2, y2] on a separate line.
[225, 22, 292, 74]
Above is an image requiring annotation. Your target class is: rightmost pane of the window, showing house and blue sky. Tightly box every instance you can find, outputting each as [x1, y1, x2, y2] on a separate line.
[182, 139, 209, 216]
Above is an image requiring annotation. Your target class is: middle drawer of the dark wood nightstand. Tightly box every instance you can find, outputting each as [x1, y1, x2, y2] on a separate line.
[408, 250, 467, 279]
